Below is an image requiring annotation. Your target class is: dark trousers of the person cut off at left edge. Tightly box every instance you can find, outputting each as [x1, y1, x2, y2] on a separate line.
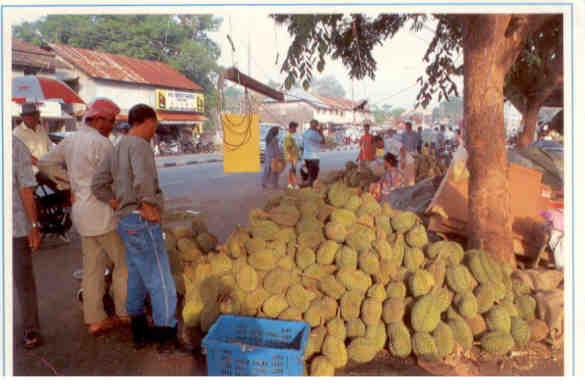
[12, 237, 40, 331]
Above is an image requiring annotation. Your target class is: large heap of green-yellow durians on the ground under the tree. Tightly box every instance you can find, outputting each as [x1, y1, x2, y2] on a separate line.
[166, 181, 547, 375]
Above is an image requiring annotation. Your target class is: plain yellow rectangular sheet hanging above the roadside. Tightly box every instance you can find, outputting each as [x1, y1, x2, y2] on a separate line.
[221, 113, 260, 173]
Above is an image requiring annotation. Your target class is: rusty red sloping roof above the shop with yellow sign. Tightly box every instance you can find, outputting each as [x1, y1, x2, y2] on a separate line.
[51, 44, 203, 91]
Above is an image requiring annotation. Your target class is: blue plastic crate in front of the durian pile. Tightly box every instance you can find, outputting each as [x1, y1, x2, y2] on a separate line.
[203, 315, 311, 376]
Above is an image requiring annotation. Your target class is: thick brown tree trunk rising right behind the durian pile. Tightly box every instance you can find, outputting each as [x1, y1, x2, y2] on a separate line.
[463, 14, 515, 264]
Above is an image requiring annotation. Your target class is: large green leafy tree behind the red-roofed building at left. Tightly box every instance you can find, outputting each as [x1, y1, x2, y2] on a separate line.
[14, 15, 222, 131]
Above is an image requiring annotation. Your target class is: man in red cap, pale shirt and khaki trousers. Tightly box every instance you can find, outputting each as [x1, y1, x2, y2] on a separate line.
[38, 98, 130, 335]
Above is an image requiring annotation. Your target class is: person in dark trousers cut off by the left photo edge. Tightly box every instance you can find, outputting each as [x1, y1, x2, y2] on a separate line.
[12, 137, 42, 349]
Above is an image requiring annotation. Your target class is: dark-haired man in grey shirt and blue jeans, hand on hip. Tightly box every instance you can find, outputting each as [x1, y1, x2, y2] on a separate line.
[92, 104, 178, 352]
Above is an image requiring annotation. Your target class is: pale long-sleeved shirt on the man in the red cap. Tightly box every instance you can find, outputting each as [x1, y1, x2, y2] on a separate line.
[39, 126, 117, 236]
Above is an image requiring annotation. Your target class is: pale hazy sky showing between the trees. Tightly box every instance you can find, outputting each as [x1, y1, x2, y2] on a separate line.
[8, 9, 462, 109]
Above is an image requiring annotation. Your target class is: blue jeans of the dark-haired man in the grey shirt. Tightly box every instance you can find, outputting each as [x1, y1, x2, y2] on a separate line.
[118, 213, 177, 327]
